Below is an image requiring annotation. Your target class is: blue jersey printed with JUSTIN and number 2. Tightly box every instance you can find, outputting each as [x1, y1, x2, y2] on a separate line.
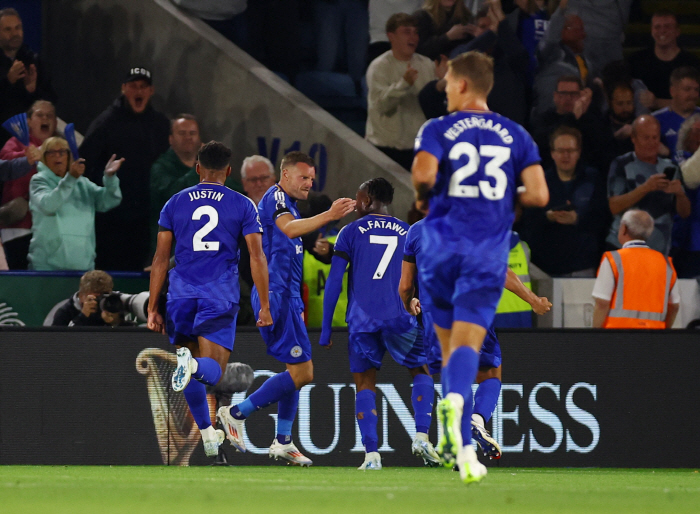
[158, 182, 262, 303]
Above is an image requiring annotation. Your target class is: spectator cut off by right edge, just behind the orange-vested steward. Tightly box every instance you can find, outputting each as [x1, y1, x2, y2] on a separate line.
[671, 114, 700, 278]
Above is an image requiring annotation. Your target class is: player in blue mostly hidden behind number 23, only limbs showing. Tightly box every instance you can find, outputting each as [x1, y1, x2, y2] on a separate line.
[399, 220, 552, 459]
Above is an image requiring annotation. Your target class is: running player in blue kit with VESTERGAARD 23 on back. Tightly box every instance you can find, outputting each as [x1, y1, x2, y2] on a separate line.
[412, 52, 549, 483]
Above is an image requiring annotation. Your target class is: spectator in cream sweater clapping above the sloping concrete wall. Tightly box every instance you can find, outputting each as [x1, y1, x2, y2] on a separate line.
[365, 13, 435, 170]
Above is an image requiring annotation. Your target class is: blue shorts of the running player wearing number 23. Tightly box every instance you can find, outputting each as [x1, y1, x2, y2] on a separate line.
[418, 248, 508, 329]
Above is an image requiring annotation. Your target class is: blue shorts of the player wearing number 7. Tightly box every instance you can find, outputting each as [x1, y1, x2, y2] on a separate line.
[348, 316, 428, 373]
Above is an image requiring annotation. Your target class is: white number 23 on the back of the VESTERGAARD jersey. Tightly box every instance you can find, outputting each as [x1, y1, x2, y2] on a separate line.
[448, 142, 510, 200]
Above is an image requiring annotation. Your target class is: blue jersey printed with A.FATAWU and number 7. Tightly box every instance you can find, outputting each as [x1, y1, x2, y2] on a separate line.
[334, 214, 415, 332]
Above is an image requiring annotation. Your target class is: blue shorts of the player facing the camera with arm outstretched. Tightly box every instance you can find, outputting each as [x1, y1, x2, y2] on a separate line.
[250, 287, 311, 364]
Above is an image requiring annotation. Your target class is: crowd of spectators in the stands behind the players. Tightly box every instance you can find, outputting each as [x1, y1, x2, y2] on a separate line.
[0, 0, 700, 324]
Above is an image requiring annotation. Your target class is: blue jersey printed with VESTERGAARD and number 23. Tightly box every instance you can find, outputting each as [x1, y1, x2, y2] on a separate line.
[415, 111, 540, 255]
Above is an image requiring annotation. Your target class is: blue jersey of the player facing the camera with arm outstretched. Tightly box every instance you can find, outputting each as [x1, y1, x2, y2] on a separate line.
[258, 184, 304, 297]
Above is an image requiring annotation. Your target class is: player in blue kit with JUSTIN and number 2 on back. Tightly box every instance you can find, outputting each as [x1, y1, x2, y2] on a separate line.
[148, 141, 272, 457]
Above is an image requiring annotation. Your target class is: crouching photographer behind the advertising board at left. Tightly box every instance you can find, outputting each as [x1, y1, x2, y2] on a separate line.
[51, 270, 114, 327]
